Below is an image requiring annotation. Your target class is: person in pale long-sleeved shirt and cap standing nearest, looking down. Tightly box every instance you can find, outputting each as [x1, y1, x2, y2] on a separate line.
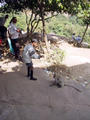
[22, 39, 40, 80]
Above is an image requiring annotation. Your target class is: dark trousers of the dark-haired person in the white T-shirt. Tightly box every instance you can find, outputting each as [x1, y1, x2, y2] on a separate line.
[11, 39, 20, 59]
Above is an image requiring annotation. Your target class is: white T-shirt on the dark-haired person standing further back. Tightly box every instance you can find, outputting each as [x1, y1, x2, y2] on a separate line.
[8, 23, 19, 39]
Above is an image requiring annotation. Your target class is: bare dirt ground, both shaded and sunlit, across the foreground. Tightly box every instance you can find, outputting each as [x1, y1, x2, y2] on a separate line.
[0, 42, 90, 120]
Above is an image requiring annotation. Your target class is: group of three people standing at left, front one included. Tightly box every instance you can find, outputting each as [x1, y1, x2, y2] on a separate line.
[0, 15, 40, 80]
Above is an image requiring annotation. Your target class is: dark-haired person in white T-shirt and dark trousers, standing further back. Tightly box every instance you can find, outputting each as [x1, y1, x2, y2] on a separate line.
[8, 17, 20, 59]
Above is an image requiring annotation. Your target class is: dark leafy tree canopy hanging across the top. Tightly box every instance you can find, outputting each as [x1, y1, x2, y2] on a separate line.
[0, 0, 87, 14]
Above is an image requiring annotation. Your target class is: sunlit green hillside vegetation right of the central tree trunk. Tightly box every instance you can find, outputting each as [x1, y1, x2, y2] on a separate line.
[46, 15, 90, 43]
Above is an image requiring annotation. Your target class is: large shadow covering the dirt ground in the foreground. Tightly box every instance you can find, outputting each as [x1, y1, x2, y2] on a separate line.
[0, 63, 90, 120]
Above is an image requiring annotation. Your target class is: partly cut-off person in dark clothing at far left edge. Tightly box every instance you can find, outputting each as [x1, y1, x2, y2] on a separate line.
[0, 15, 8, 39]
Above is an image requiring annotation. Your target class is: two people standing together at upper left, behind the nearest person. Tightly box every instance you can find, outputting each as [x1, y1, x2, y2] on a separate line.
[0, 15, 20, 59]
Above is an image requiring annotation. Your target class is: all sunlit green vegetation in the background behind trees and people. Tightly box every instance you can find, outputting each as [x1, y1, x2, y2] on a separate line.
[0, 12, 90, 44]
